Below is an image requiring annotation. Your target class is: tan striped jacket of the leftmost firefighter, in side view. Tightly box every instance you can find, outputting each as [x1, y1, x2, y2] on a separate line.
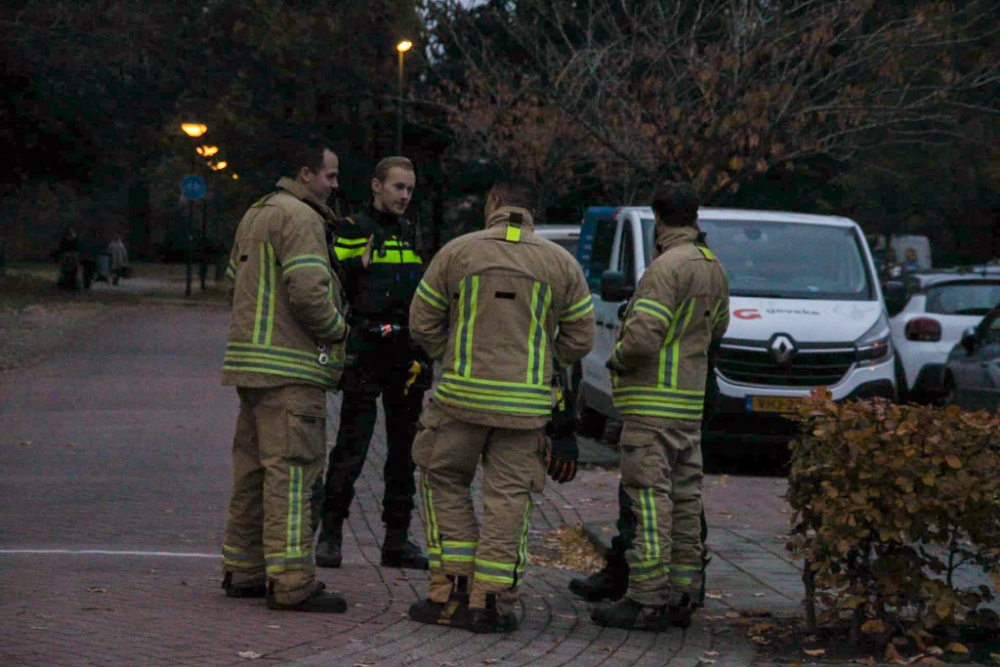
[222, 178, 347, 389]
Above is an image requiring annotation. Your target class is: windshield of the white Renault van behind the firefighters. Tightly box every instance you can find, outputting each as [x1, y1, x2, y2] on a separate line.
[642, 218, 875, 301]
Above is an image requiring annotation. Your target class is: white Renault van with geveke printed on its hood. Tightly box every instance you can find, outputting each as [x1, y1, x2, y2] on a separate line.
[578, 207, 896, 440]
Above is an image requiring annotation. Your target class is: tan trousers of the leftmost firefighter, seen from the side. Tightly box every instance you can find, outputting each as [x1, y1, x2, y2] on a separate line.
[222, 385, 326, 605]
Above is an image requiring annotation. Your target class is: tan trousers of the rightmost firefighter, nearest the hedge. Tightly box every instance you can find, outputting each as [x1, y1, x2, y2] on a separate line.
[621, 417, 704, 606]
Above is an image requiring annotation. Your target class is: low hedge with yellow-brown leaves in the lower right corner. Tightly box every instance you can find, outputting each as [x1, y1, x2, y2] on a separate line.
[788, 390, 1000, 643]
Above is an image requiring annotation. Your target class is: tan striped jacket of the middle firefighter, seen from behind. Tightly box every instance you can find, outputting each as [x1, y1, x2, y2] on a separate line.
[410, 207, 594, 429]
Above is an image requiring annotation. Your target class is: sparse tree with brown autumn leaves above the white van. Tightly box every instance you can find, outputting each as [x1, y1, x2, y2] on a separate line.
[427, 0, 1000, 203]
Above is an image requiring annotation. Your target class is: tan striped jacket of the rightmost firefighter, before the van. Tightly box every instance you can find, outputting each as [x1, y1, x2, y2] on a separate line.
[608, 227, 729, 420]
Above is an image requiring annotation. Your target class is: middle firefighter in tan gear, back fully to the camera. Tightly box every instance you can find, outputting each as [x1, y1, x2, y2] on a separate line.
[410, 183, 594, 632]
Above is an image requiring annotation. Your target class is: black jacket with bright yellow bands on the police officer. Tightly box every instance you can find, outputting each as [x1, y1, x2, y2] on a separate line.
[334, 204, 423, 327]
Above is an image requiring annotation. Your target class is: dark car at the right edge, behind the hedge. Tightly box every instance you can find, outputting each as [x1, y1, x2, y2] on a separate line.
[942, 306, 1000, 411]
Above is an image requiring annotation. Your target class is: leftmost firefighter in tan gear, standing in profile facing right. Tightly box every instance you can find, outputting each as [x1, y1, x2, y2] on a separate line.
[222, 143, 347, 612]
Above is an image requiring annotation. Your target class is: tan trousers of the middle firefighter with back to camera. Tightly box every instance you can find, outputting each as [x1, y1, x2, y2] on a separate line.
[413, 402, 547, 611]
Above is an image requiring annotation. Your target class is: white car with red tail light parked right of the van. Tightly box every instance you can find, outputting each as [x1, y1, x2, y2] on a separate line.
[889, 273, 1000, 403]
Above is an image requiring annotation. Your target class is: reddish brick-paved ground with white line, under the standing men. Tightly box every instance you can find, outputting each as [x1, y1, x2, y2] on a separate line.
[0, 307, 800, 667]
